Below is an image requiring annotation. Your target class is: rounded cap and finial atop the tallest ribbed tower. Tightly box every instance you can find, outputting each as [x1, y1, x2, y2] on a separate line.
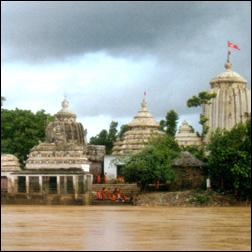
[210, 62, 247, 84]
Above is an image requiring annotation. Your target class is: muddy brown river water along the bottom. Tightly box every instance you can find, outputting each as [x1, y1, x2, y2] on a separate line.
[1, 205, 251, 251]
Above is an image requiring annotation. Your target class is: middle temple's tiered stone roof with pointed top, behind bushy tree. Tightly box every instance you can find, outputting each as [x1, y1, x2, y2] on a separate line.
[112, 97, 163, 156]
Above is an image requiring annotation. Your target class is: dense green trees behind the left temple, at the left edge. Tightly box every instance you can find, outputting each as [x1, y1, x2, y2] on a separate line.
[1, 108, 53, 166]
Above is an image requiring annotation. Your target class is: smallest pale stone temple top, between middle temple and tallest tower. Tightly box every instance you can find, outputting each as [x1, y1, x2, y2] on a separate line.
[175, 121, 202, 146]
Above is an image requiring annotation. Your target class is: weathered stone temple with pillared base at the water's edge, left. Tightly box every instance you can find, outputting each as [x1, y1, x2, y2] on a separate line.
[1, 99, 105, 203]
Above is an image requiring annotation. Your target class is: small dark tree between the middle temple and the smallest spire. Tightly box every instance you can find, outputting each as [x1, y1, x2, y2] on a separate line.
[159, 110, 178, 137]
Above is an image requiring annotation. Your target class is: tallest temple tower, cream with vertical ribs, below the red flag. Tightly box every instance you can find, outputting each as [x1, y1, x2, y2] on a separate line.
[203, 56, 251, 139]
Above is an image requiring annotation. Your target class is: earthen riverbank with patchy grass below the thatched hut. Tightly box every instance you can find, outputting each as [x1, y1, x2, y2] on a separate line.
[134, 190, 251, 207]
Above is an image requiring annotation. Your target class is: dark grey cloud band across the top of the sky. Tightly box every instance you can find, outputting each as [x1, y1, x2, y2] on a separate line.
[2, 1, 249, 61]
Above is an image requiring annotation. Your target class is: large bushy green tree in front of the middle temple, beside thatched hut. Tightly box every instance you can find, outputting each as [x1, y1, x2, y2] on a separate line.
[122, 135, 179, 189]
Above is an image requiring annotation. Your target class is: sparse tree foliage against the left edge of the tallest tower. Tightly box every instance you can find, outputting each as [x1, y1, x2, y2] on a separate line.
[187, 91, 216, 139]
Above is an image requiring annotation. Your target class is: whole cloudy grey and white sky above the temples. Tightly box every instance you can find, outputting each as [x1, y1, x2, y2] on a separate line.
[1, 1, 251, 140]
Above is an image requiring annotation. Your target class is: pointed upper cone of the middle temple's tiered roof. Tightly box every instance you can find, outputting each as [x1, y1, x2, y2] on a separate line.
[128, 98, 159, 128]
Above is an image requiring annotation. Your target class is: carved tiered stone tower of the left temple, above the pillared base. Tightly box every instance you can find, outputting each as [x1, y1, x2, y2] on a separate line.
[26, 99, 89, 169]
